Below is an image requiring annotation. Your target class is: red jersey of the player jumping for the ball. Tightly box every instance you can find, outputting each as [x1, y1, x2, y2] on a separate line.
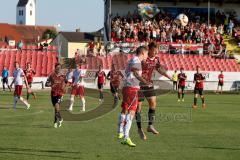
[142, 57, 160, 82]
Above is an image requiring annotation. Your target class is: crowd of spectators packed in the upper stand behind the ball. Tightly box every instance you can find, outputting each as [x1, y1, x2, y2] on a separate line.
[111, 12, 238, 45]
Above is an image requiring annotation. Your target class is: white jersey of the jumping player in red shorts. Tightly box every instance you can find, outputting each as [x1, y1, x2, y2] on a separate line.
[124, 56, 142, 88]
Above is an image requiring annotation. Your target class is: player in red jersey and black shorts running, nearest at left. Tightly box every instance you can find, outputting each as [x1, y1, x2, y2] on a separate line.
[45, 63, 66, 128]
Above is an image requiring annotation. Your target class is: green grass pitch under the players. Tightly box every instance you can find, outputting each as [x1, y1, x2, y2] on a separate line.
[0, 91, 240, 160]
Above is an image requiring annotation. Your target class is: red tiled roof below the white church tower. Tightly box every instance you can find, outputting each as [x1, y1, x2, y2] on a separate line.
[0, 23, 56, 43]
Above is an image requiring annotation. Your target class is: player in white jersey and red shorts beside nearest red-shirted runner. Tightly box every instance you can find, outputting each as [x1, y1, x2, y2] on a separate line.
[69, 63, 86, 111]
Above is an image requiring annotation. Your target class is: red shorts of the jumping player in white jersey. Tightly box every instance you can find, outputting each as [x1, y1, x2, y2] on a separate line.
[122, 87, 139, 112]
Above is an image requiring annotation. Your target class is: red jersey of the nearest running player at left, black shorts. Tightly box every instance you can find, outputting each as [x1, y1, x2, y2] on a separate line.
[48, 72, 66, 96]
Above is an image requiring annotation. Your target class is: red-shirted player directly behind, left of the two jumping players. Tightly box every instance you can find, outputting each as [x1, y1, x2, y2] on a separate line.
[107, 64, 124, 103]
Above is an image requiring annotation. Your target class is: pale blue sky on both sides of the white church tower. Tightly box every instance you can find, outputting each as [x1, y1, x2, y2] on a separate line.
[0, 0, 104, 32]
